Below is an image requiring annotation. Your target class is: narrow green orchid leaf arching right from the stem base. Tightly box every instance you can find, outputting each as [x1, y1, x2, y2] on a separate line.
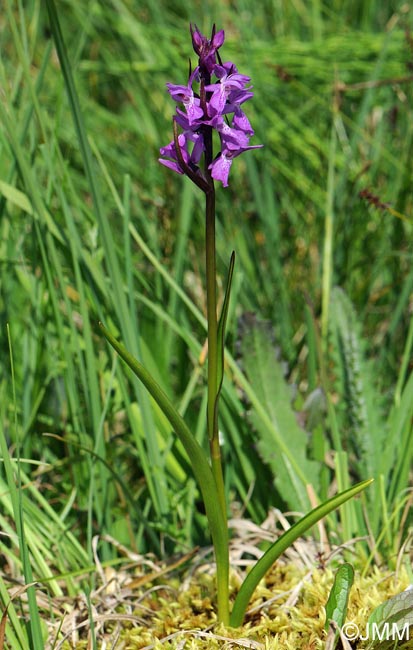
[230, 479, 373, 627]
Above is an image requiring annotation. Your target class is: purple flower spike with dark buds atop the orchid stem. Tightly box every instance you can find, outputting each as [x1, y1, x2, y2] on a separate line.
[160, 25, 262, 186]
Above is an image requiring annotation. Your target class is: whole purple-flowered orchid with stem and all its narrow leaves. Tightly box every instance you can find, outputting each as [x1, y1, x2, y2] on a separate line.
[101, 25, 371, 627]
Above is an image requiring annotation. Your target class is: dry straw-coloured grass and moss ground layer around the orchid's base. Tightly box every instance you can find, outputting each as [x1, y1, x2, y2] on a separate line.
[4, 511, 409, 650]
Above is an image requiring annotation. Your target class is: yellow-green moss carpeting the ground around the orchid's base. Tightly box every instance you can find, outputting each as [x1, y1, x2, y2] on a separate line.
[50, 541, 409, 650]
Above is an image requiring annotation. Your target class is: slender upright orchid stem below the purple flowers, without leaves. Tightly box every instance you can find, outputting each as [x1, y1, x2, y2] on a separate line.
[205, 179, 229, 623]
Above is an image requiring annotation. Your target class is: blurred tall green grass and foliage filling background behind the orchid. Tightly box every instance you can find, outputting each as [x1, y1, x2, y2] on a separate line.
[0, 0, 413, 650]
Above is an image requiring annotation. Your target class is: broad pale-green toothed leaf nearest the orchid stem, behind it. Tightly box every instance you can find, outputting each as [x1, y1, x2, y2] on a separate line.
[240, 316, 320, 510]
